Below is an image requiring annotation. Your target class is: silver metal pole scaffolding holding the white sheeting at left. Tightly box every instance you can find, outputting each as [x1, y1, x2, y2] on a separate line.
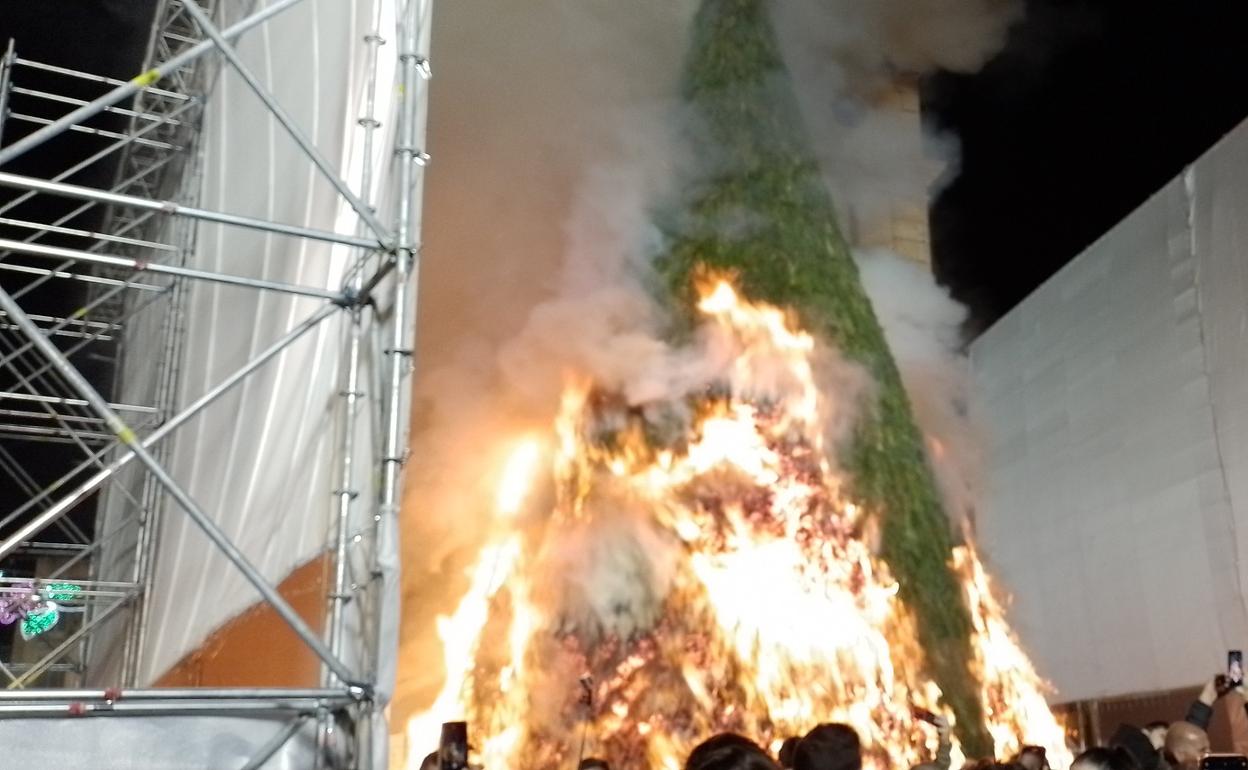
[0, 0, 431, 768]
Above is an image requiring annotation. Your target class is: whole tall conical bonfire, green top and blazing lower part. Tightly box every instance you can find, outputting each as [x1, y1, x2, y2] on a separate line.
[408, 0, 1070, 770]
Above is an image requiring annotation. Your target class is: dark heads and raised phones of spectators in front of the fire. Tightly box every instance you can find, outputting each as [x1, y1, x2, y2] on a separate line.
[421, 675, 1248, 770]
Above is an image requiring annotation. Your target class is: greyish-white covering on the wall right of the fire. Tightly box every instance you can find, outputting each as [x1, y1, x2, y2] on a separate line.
[972, 117, 1248, 700]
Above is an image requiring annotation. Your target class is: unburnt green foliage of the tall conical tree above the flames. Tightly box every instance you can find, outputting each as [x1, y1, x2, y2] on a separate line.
[658, 0, 992, 756]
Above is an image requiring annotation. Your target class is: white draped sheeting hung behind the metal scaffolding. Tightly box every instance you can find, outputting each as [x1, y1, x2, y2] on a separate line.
[110, 0, 416, 695]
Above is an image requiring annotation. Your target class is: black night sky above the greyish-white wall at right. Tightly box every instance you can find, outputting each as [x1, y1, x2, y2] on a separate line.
[925, 0, 1248, 333]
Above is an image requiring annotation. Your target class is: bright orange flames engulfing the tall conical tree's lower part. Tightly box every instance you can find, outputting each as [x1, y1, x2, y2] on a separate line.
[408, 281, 1070, 770]
